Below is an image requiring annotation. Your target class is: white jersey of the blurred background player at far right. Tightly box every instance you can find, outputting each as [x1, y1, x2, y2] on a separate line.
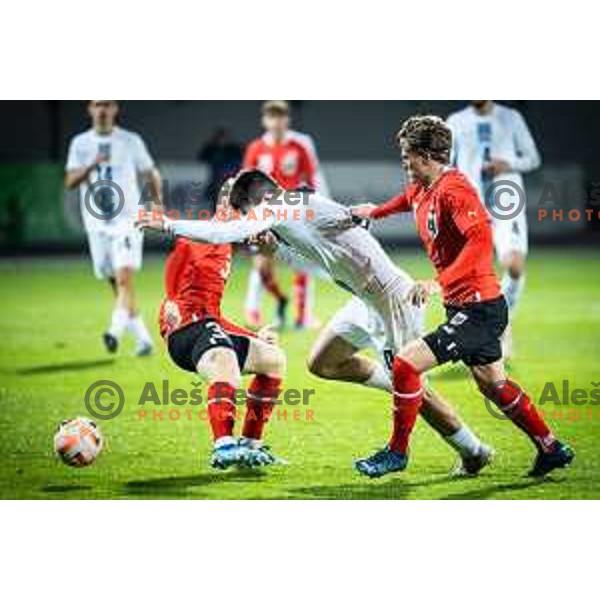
[448, 103, 541, 200]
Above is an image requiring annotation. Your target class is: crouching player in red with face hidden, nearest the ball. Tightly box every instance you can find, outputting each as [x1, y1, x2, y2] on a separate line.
[160, 230, 286, 469]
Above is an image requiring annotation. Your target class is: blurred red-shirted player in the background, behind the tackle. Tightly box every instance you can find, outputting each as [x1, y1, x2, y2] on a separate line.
[244, 100, 327, 329]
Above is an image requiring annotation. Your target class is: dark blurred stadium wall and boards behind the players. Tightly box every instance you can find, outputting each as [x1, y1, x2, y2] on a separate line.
[0, 101, 600, 254]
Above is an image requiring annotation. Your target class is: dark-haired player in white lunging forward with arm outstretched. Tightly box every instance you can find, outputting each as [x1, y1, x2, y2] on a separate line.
[139, 170, 492, 475]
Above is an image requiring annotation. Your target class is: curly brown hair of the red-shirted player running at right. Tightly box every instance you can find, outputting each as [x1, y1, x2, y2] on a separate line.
[396, 115, 452, 164]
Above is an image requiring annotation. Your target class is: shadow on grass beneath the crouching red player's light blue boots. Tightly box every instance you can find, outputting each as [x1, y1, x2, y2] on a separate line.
[125, 470, 265, 496]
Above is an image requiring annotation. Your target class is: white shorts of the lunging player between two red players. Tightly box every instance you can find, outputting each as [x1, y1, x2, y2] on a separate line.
[326, 296, 424, 355]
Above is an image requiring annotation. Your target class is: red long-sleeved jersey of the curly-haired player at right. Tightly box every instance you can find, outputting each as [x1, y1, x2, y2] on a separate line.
[371, 169, 500, 305]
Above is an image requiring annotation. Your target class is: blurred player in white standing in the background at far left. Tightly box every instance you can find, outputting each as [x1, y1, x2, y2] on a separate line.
[65, 100, 161, 356]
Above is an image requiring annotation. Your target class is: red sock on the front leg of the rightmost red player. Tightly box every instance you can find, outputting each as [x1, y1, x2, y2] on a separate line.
[389, 356, 423, 454]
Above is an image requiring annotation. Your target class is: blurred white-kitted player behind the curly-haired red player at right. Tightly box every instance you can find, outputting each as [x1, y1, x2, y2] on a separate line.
[448, 100, 541, 355]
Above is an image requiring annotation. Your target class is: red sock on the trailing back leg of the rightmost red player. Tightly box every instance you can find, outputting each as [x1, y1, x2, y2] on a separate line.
[486, 381, 556, 452]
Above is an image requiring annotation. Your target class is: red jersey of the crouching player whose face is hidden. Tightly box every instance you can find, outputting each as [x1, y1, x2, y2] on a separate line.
[159, 238, 254, 337]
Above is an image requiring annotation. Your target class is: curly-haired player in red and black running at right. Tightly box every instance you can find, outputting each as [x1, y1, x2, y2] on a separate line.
[353, 116, 574, 477]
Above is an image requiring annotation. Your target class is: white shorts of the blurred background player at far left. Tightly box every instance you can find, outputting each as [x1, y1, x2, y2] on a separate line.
[88, 228, 144, 279]
